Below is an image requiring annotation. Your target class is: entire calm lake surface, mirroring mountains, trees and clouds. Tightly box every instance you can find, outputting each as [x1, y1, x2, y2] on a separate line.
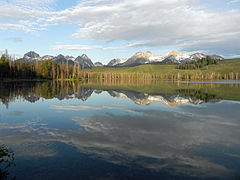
[0, 82, 240, 180]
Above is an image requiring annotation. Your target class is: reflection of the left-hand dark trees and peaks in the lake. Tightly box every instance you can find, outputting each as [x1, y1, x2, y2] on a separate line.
[0, 80, 93, 107]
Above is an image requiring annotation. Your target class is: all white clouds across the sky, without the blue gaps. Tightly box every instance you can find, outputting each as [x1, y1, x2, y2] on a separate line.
[0, 0, 240, 55]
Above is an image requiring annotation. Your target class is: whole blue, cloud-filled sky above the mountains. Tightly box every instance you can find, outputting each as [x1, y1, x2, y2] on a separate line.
[0, 0, 240, 64]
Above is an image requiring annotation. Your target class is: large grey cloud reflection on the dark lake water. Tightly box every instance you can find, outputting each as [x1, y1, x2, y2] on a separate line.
[0, 103, 240, 179]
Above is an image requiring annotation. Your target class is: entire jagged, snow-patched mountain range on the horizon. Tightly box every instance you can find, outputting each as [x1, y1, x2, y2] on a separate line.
[19, 50, 224, 68]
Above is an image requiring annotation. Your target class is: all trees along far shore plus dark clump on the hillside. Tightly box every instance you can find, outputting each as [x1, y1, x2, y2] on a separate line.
[0, 55, 240, 80]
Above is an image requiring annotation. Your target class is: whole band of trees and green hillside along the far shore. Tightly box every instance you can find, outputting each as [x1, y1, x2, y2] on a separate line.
[0, 55, 240, 83]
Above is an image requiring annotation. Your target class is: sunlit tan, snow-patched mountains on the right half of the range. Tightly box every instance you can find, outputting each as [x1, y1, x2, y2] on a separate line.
[108, 50, 224, 66]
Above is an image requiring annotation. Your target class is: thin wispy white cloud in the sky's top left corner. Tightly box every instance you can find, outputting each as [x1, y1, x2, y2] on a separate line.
[0, 0, 55, 32]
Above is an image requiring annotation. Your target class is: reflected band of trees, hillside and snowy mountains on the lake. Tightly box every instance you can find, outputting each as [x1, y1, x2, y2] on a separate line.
[0, 81, 240, 107]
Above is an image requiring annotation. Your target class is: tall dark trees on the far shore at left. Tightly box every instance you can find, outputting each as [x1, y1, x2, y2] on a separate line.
[0, 55, 84, 80]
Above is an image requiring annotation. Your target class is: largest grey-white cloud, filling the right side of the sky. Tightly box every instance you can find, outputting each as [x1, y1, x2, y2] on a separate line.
[53, 0, 240, 54]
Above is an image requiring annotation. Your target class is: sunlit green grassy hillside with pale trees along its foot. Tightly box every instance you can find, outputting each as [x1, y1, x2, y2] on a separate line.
[85, 59, 240, 80]
